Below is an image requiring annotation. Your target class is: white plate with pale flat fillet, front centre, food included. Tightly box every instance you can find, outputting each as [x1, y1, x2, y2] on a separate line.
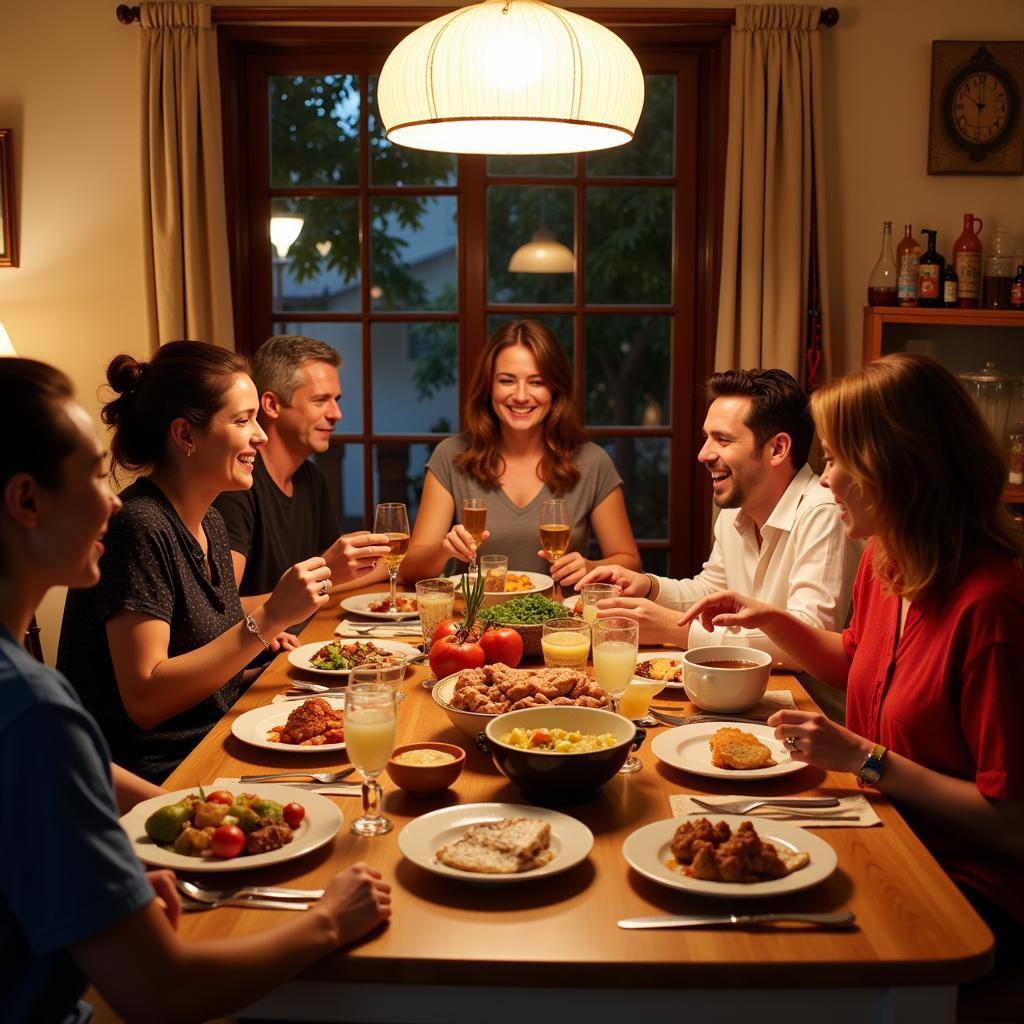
[398, 803, 594, 885]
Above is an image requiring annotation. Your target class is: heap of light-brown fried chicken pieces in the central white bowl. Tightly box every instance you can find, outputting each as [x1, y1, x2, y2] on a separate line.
[452, 663, 608, 715]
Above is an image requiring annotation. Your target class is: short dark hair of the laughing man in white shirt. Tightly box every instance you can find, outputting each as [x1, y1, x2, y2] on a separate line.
[706, 370, 814, 469]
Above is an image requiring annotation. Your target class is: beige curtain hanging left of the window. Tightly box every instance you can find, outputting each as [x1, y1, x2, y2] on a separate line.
[141, 2, 234, 348]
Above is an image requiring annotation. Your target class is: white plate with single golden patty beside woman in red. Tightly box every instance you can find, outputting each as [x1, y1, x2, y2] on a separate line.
[650, 722, 807, 781]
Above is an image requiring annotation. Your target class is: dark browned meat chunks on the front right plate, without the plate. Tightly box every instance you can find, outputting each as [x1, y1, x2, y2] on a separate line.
[672, 818, 811, 884]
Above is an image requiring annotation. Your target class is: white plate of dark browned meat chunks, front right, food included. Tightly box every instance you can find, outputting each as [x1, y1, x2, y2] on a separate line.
[623, 814, 839, 898]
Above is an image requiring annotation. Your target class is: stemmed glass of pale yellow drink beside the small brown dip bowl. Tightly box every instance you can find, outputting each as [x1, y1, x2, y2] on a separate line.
[345, 683, 394, 836]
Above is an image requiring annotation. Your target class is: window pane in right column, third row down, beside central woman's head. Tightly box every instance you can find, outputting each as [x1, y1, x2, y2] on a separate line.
[585, 316, 672, 427]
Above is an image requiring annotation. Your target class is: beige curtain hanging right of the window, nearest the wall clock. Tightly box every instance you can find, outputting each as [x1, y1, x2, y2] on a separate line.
[715, 4, 828, 380]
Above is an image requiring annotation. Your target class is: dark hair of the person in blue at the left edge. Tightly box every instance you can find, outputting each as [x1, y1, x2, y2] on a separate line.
[0, 357, 78, 490]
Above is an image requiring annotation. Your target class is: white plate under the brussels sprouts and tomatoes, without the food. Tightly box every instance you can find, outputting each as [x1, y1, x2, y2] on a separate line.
[121, 782, 342, 874]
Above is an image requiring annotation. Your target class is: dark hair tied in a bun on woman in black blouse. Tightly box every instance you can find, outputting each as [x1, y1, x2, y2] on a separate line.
[100, 341, 249, 472]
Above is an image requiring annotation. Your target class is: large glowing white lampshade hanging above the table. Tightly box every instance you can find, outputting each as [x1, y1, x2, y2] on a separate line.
[377, 0, 644, 154]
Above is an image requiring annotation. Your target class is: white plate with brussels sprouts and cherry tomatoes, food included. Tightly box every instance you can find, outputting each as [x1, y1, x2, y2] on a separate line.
[121, 782, 342, 874]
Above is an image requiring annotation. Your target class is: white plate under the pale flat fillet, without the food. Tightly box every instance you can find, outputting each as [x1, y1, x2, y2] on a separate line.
[398, 804, 594, 885]
